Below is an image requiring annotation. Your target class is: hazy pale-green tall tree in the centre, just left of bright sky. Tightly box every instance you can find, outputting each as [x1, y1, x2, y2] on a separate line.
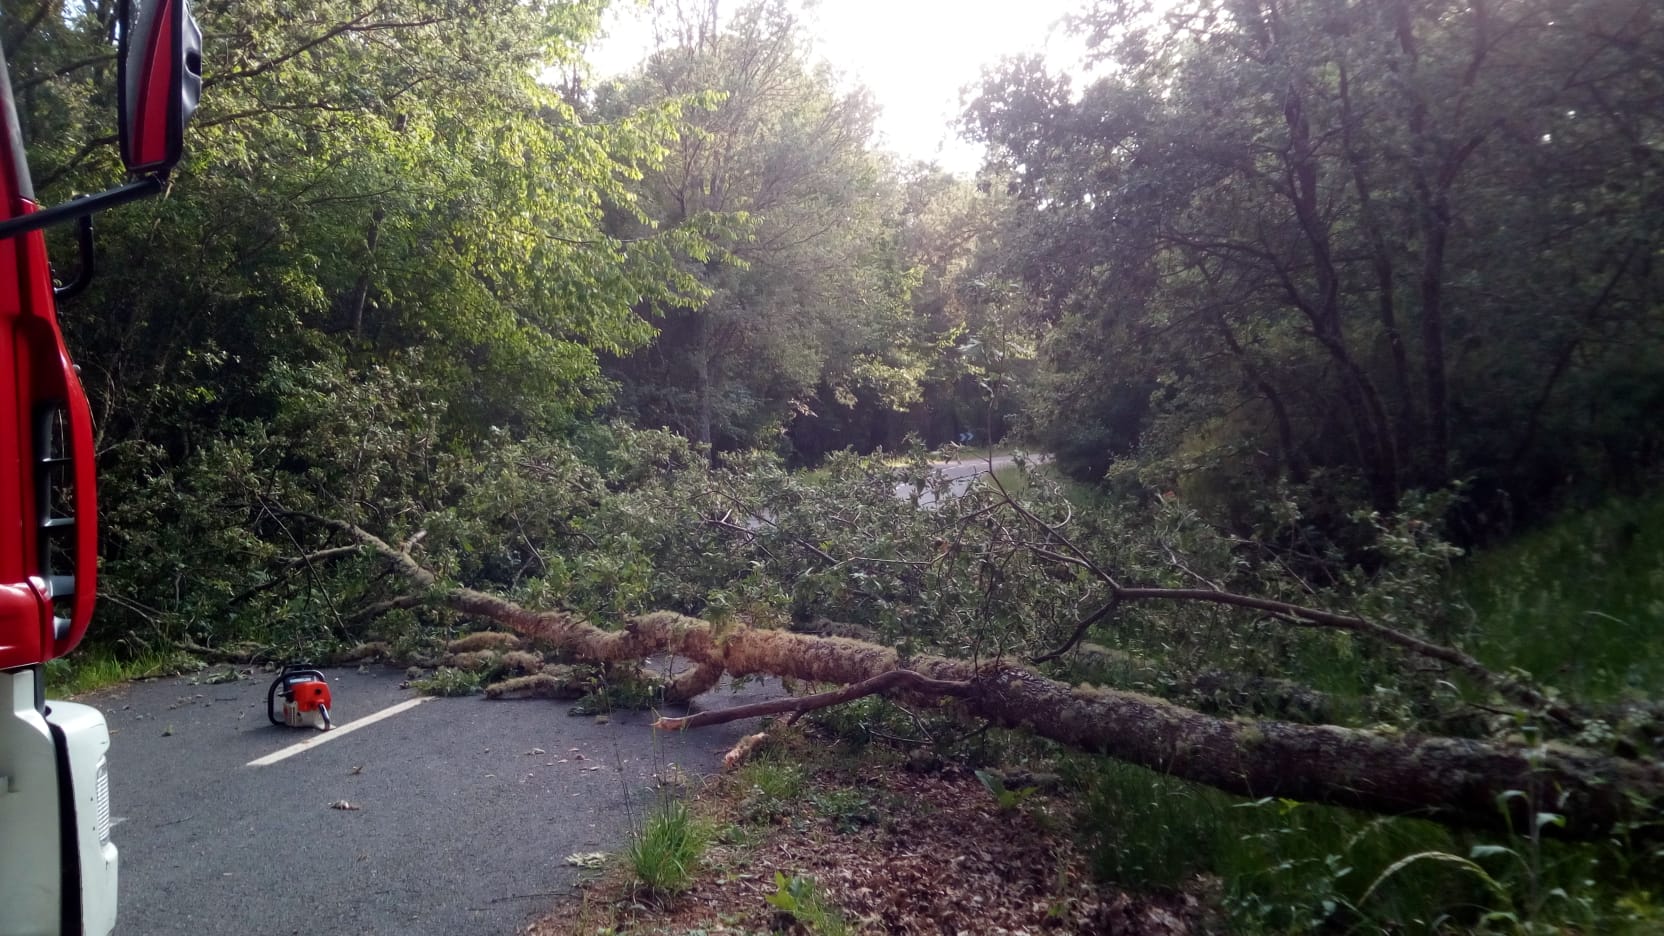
[599, 2, 917, 448]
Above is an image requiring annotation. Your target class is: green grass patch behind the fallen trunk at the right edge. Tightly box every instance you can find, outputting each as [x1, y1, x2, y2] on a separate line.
[1454, 495, 1664, 701]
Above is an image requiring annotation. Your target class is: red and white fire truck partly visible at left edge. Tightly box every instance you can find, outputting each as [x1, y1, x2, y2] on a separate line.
[0, 0, 201, 936]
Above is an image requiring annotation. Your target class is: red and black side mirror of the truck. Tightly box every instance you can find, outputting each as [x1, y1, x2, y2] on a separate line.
[116, 0, 203, 175]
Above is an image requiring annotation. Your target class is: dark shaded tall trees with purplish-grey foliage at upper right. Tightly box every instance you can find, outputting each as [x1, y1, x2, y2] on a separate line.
[968, 0, 1664, 506]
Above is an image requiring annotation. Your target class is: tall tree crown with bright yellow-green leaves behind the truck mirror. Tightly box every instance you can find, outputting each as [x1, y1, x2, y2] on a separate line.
[7, 0, 712, 438]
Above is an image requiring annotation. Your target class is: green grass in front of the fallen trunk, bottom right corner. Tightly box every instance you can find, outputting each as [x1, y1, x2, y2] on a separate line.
[1065, 758, 1664, 933]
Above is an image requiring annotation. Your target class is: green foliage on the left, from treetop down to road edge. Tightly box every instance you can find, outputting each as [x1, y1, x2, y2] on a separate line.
[5, 0, 722, 653]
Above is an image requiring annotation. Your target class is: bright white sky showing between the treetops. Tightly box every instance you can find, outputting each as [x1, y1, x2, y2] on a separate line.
[589, 0, 1085, 175]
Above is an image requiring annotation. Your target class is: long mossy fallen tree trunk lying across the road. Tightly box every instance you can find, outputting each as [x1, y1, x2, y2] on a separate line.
[319, 520, 1664, 839]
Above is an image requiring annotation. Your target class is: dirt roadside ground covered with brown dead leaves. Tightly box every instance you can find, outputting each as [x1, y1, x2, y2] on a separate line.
[526, 736, 1208, 936]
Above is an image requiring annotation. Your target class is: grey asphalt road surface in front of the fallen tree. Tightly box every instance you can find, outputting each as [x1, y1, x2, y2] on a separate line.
[89, 666, 779, 936]
